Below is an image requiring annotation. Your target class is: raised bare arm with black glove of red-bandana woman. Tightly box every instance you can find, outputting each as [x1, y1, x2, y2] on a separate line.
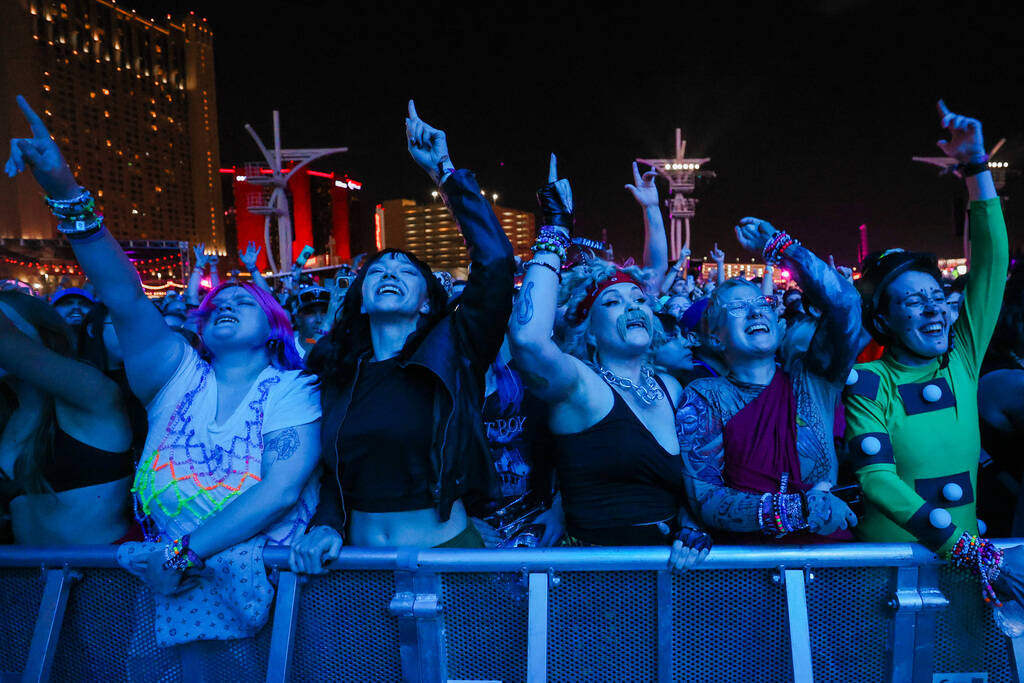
[509, 155, 582, 403]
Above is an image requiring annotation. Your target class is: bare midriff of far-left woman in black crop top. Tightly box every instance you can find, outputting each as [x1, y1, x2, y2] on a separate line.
[10, 476, 132, 546]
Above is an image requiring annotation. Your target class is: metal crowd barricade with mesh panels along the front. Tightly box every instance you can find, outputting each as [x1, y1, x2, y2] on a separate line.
[0, 540, 1024, 683]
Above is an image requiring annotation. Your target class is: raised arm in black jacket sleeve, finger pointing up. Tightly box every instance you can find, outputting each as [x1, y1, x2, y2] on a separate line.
[406, 100, 515, 372]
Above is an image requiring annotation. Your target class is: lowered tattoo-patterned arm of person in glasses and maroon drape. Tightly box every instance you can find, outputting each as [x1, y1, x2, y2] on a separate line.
[676, 388, 761, 531]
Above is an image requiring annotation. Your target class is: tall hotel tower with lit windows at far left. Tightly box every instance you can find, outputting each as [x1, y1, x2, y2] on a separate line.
[0, 0, 225, 254]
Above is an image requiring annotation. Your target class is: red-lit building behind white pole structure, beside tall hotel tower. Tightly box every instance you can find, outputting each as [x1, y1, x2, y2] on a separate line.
[220, 163, 362, 270]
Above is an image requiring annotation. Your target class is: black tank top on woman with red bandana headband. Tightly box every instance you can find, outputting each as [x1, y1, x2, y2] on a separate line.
[555, 381, 684, 545]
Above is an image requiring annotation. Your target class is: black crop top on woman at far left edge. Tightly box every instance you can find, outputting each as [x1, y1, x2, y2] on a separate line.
[42, 427, 135, 493]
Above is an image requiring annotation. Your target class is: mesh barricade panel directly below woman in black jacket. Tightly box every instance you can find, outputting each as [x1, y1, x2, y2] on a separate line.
[290, 571, 401, 683]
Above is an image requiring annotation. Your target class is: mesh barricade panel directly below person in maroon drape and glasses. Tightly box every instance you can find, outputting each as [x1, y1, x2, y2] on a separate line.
[672, 569, 790, 683]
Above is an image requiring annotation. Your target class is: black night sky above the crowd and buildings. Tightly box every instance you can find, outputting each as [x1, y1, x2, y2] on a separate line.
[132, 0, 1024, 263]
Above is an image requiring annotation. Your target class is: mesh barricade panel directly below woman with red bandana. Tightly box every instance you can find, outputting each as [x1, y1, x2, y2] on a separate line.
[548, 571, 657, 683]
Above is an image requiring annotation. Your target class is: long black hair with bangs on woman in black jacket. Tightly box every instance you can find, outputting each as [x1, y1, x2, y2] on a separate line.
[306, 249, 449, 386]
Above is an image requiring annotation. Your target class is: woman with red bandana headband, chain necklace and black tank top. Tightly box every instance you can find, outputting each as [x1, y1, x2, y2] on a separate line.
[510, 157, 711, 568]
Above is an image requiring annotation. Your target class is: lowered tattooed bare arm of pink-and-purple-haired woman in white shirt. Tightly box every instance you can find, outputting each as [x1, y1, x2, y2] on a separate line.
[190, 420, 319, 559]
